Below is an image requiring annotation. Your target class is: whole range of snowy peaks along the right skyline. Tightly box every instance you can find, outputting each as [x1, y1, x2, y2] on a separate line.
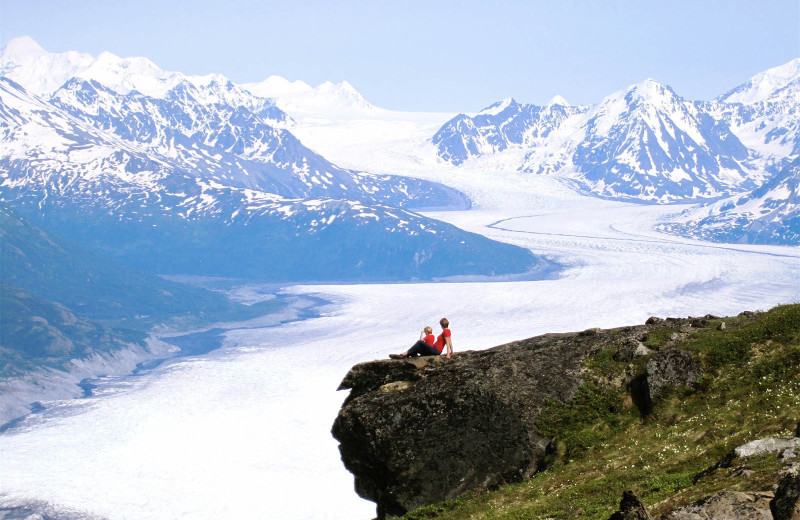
[433, 59, 800, 207]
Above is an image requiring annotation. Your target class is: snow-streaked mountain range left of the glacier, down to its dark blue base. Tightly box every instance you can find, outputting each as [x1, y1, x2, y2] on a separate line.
[0, 39, 539, 281]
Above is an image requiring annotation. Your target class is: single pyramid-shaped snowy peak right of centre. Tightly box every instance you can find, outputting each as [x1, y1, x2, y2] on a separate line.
[556, 79, 755, 202]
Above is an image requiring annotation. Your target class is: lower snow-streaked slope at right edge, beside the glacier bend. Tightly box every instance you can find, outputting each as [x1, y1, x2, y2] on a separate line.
[660, 157, 800, 246]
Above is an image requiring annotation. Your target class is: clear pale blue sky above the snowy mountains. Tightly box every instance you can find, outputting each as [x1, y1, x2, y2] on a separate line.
[0, 0, 800, 111]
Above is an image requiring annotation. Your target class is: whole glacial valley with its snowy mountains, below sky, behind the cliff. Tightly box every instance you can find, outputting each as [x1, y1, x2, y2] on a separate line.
[0, 38, 800, 520]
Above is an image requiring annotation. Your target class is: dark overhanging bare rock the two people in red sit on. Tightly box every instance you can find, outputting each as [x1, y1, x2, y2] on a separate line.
[332, 332, 608, 517]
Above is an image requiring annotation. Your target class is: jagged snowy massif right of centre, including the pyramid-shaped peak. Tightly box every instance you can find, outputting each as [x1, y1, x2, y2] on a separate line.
[432, 79, 760, 202]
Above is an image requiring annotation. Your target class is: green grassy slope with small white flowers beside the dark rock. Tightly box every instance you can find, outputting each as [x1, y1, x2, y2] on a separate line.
[404, 304, 800, 520]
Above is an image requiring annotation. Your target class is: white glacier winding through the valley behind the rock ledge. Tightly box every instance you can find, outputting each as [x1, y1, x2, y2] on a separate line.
[0, 180, 800, 520]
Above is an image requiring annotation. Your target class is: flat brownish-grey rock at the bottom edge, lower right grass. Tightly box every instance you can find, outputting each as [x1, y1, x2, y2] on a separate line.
[660, 491, 772, 520]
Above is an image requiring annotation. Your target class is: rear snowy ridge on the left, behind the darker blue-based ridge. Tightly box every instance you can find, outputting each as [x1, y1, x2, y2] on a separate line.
[1, 38, 456, 207]
